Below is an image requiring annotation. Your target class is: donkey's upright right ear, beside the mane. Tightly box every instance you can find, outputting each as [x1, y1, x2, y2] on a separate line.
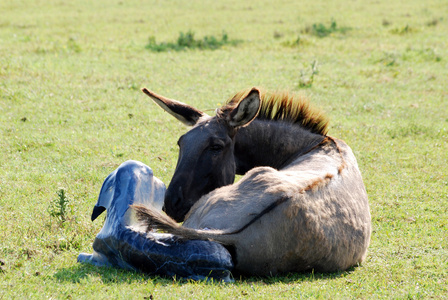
[227, 88, 261, 127]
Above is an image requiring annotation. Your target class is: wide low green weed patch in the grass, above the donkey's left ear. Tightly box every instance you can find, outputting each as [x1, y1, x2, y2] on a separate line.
[146, 30, 240, 52]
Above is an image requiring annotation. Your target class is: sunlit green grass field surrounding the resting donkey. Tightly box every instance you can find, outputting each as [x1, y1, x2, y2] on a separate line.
[0, 0, 448, 299]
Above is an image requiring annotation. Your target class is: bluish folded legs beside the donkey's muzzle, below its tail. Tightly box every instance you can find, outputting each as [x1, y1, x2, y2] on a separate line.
[78, 161, 233, 281]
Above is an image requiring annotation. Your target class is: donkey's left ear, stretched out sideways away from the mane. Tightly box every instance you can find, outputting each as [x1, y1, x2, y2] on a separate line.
[142, 88, 205, 126]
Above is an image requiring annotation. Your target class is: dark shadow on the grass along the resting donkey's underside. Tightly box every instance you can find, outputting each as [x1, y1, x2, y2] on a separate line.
[54, 264, 355, 285]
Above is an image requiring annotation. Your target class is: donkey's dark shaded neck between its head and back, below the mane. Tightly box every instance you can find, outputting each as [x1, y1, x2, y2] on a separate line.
[234, 120, 325, 174]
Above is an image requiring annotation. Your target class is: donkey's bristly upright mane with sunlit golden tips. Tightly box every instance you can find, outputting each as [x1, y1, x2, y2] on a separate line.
[217, 89, 329, 135]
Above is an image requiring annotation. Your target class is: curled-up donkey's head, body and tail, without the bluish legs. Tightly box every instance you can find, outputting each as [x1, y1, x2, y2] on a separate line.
[133, 88, 371, 275]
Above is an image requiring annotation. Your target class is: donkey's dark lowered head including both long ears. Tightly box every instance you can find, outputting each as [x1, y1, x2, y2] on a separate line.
[142, 88, 260, 222]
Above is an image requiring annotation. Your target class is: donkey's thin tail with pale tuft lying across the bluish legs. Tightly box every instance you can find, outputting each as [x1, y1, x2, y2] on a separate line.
[131, 205, 233, 244]
